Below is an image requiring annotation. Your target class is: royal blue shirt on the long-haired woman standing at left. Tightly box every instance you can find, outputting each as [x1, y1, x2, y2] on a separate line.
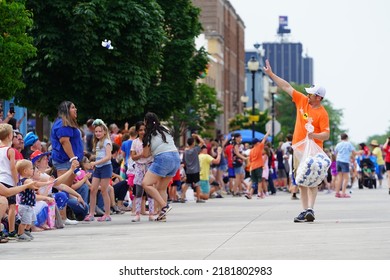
[50, 118, 84, 163]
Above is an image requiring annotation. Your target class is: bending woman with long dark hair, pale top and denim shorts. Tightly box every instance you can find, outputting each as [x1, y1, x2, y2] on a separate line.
[142, 112, 180, 221]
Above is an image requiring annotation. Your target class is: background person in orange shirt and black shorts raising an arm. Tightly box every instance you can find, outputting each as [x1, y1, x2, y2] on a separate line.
[245, 131, 269, 199]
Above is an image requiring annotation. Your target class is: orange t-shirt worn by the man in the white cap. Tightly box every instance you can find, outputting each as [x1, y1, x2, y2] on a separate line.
[292, 90, 330, 148]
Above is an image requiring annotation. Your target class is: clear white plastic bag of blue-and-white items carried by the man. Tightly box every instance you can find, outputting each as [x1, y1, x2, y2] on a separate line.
[292, 123, 331, 187]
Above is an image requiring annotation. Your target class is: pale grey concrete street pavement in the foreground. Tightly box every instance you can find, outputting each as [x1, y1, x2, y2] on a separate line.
[0, 185, 390, 260]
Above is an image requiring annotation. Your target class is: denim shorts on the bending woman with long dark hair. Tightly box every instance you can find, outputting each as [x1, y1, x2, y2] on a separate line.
[149, 152, 180, 177]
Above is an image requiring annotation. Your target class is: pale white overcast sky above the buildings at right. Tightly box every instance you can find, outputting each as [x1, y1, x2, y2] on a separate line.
[229, 0, 390, 143]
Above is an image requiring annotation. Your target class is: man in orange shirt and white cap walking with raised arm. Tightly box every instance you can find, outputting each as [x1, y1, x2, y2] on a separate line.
[264, 60, 330, 222]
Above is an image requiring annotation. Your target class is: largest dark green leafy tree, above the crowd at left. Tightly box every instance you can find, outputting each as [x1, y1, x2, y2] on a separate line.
[16, 0, 166, 121]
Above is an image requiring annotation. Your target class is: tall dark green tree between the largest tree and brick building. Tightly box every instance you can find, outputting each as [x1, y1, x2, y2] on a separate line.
[146, 0, 208, 119]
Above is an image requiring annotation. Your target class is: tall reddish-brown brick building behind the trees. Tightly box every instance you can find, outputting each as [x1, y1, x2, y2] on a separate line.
[192, 0, 245, 134]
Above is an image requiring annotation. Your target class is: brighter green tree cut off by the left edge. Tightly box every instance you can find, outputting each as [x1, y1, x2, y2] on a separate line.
[0, 0, 36, 99]
